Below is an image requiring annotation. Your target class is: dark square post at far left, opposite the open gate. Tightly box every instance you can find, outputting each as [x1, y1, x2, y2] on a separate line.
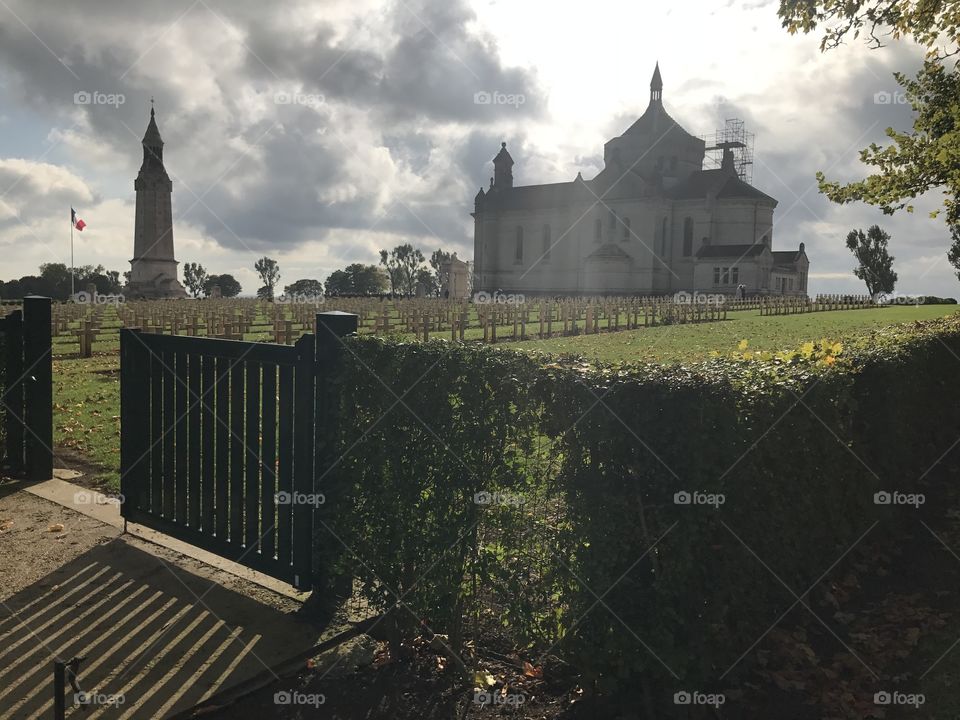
[23, 295, 53, 480]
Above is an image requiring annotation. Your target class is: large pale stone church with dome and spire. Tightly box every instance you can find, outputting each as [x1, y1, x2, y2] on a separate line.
[472, 65, 809, 295]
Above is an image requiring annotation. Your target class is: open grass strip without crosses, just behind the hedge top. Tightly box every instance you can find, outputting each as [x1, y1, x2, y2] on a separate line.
[502, 305, 960, 363]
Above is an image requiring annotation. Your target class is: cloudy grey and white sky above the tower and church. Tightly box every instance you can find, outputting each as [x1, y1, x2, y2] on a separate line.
[0, 0, 948, 295]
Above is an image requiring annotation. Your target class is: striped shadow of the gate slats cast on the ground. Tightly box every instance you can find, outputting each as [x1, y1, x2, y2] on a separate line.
[0, 538, 322, 720]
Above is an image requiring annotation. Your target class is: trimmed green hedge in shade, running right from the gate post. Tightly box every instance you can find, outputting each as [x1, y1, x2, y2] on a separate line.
[316, 318, 960, 704]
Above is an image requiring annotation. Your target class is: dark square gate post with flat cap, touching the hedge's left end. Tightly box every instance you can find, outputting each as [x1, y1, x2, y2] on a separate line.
[313, 311, 359, 600]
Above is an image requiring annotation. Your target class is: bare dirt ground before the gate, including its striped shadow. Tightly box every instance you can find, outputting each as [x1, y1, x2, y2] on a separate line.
[0, 484, 331, 719]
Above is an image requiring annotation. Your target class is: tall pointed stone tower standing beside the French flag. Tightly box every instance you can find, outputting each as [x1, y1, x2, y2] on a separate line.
[124, 106, 187, 299]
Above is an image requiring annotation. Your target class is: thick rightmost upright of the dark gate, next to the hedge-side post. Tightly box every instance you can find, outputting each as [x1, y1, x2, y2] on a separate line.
[291, 334, 316, 589]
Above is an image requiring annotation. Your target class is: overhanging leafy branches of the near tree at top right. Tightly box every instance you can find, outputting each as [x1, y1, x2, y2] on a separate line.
[780, 0, 960, 270]
